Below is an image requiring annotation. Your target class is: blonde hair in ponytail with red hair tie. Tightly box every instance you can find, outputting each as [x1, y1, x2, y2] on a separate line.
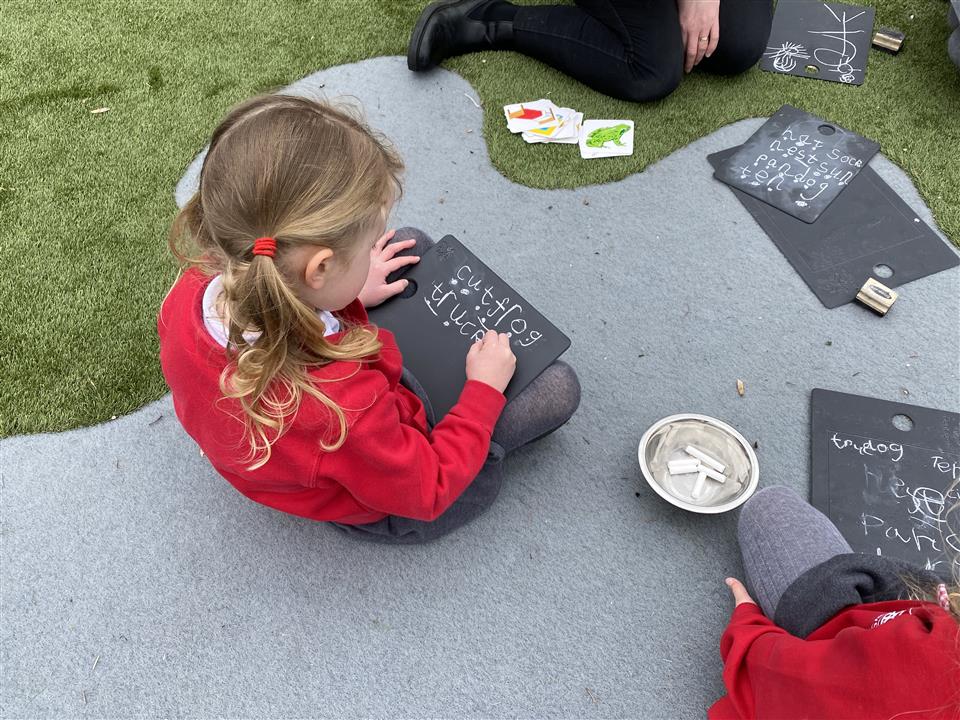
[169, 95, 403, 470]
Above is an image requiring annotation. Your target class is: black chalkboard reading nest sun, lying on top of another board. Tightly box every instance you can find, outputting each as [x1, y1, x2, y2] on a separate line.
[714, 105, 880, 223]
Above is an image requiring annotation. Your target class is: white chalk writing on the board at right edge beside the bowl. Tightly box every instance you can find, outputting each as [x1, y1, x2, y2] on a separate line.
[830, 432, 960, 570]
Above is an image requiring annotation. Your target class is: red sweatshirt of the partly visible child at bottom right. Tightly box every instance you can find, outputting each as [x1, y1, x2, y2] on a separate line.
[707, 600, 960, 720]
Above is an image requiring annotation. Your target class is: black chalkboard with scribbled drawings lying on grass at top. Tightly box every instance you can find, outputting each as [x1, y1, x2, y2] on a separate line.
[760, 0, 874, 85]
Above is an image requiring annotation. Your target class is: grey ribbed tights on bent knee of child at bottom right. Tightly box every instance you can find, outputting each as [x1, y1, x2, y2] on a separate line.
[737, 486, 853, 618]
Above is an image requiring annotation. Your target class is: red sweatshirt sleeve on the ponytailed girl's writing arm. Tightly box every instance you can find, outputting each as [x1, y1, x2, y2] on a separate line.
[319, 380, 506, 520]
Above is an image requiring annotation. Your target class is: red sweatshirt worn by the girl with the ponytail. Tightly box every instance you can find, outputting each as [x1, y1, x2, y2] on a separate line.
[157, 269, 506, 525]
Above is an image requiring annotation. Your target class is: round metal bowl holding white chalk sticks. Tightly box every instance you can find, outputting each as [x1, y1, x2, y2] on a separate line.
[637, 413, 760, 514]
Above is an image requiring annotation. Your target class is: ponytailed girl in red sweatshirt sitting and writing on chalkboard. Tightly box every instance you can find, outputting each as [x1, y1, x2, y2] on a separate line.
[158, 95, 580, 542]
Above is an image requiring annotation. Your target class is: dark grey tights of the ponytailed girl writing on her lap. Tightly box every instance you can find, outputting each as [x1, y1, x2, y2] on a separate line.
[334, 228, 580, 544]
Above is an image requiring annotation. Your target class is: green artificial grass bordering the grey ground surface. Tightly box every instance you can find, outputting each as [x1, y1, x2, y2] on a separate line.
[0, 0, 960, 436]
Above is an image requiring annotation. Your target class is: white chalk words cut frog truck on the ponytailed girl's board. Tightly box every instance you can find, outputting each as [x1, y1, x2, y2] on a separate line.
[423, 265, 543, 348]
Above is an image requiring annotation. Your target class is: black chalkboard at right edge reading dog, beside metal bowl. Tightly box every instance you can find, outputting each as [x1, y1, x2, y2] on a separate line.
[810, 389, 960, 577]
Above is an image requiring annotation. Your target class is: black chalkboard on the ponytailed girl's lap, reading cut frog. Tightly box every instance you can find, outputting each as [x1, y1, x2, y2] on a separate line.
[369, 235, 570, 420]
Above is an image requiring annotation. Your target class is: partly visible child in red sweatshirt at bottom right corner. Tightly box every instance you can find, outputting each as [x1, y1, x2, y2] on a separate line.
[708, 487, 960, 720]
